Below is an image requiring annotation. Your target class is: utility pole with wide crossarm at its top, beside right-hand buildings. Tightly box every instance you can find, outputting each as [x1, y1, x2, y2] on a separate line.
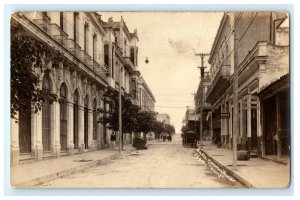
[195, 53, 209, 149]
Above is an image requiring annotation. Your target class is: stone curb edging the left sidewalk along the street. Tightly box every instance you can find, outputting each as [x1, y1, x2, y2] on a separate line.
[14, 149, 135, 188]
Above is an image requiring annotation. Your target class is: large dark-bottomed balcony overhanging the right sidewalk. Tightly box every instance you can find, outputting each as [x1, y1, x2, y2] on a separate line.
[206, 65, 230, 105]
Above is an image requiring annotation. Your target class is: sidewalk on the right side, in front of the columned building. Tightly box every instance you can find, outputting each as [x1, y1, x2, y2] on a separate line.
[203, 142, 290, 188]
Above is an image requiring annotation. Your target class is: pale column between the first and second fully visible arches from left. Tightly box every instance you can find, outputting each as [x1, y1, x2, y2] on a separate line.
[51, 101, 61, 157]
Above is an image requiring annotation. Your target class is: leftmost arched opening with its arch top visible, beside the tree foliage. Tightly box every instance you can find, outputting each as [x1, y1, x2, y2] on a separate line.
[42, 75, 51, 151]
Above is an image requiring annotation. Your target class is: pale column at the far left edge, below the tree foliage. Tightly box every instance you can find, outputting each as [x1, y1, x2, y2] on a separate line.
[10, 113, 20, 166]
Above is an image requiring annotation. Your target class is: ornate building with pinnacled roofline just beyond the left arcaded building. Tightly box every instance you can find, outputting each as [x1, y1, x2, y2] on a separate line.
[101, 17, 140, 143]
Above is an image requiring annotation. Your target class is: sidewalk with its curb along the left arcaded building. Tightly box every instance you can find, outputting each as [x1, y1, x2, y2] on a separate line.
[10, 144, 135, 188]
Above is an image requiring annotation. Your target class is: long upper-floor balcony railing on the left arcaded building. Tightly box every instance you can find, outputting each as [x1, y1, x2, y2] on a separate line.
[33, 16, 108, 80]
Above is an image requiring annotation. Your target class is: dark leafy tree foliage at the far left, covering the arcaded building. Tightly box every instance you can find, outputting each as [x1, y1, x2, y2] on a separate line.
[10, 19, 61, 119]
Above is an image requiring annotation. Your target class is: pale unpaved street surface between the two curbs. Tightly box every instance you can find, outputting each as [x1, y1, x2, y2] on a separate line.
[37, 135, 241, 188]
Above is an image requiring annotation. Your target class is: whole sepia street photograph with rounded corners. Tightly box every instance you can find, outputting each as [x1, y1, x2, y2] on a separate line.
[9, 10, 293, 189]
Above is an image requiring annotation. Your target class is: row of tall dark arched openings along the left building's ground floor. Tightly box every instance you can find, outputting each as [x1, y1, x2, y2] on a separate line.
[19, 74, 106, 153]
